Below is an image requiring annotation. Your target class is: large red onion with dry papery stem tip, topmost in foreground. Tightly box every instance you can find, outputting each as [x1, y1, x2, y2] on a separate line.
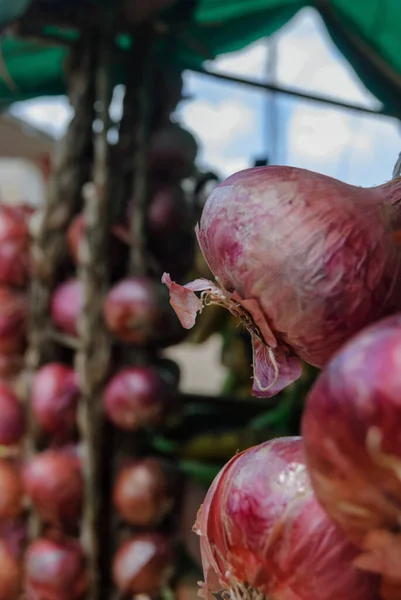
[163, 166, 401, 396]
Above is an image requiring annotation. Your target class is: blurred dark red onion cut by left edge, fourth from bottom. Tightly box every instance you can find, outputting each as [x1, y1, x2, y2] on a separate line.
[0, 286, 27, 355]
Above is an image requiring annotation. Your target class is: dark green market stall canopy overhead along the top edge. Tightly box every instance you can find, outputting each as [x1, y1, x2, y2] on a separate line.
[0, 0, 401, 117]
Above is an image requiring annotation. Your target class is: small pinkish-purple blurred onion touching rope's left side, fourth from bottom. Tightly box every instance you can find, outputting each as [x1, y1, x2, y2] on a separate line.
[51, 279, 83, 336]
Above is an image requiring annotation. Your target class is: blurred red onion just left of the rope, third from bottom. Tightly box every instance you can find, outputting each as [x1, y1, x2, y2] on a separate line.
[31, 363, 80, 441]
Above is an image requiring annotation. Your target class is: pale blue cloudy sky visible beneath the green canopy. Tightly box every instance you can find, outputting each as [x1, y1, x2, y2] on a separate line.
[10, 9, 401, 186]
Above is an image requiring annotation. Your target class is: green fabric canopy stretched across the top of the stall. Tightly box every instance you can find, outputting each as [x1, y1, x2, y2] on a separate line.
[0, 0, 401, 117]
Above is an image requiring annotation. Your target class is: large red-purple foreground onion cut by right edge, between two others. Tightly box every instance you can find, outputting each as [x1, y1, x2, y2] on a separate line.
[302, 316, 401, 593]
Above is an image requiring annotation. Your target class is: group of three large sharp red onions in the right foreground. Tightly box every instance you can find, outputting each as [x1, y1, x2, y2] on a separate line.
[171, 166, 401, 600]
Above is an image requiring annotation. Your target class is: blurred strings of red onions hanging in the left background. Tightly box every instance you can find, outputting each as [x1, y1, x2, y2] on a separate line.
[0, 58, 203, 600]
